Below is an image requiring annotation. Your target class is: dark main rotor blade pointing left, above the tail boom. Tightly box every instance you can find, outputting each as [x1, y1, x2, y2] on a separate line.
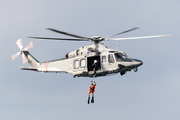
[28, 37, 89, 41]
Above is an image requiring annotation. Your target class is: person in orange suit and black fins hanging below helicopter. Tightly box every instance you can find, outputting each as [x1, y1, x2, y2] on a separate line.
[88, 81, 96, 104]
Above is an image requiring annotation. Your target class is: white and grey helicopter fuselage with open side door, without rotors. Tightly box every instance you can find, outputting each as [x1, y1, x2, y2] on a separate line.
[21, 43, 142, 77]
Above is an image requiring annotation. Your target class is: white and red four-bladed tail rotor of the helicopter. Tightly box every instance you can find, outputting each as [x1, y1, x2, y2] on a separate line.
[11, 39, 33, 64]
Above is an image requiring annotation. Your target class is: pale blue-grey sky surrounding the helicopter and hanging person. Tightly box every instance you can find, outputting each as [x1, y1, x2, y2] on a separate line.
[0, 0, 180, 120]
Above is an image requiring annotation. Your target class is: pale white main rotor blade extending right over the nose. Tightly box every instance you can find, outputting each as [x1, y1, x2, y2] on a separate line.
[106, 34, 170, 40]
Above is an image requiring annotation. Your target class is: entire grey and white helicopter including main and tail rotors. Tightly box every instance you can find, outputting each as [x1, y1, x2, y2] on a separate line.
[11, 27, 169, 78]
